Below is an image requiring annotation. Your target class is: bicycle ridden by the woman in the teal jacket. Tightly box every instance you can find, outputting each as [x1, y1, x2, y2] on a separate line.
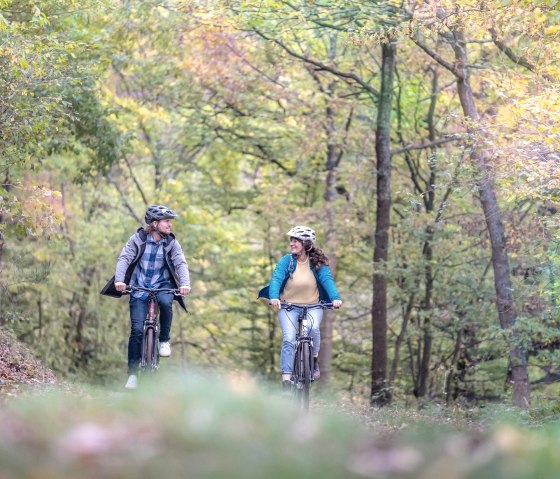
[280, 301, 334, 410]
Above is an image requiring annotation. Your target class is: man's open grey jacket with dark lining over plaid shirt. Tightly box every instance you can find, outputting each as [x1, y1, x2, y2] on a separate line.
[101, 228, 190, 311]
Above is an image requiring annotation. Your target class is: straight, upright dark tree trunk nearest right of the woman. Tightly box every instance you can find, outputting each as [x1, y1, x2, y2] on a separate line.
[370, 41, 396, 406]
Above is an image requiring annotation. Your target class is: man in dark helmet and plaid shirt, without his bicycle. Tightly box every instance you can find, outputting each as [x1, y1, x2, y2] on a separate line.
[101, 205, 191, 389]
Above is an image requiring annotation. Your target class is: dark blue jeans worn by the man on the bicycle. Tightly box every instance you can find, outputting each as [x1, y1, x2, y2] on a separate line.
[128, 293, 173, 374]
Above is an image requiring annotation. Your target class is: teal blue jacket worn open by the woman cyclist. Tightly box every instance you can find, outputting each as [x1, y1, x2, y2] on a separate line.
[259, 254, 340, 303]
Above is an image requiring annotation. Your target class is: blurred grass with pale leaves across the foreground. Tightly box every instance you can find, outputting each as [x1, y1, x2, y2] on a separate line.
[0, 375, 560, 479]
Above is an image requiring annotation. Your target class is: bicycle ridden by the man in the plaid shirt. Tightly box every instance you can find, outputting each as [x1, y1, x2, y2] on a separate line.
[123, 286, 180, 373]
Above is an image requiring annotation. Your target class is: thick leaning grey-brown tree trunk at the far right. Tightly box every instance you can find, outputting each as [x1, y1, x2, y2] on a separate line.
[453, 31, 530, 408]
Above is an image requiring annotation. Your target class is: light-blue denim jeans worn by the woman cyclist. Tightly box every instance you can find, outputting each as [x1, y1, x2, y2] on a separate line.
[278, 305, 323, 373]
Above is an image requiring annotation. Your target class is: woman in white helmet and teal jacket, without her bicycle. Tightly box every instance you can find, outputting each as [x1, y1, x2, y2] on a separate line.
[259, 226, 342, 389]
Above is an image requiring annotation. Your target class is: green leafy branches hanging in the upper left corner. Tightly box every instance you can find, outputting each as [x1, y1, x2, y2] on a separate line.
[0, 0, 116, 234]
